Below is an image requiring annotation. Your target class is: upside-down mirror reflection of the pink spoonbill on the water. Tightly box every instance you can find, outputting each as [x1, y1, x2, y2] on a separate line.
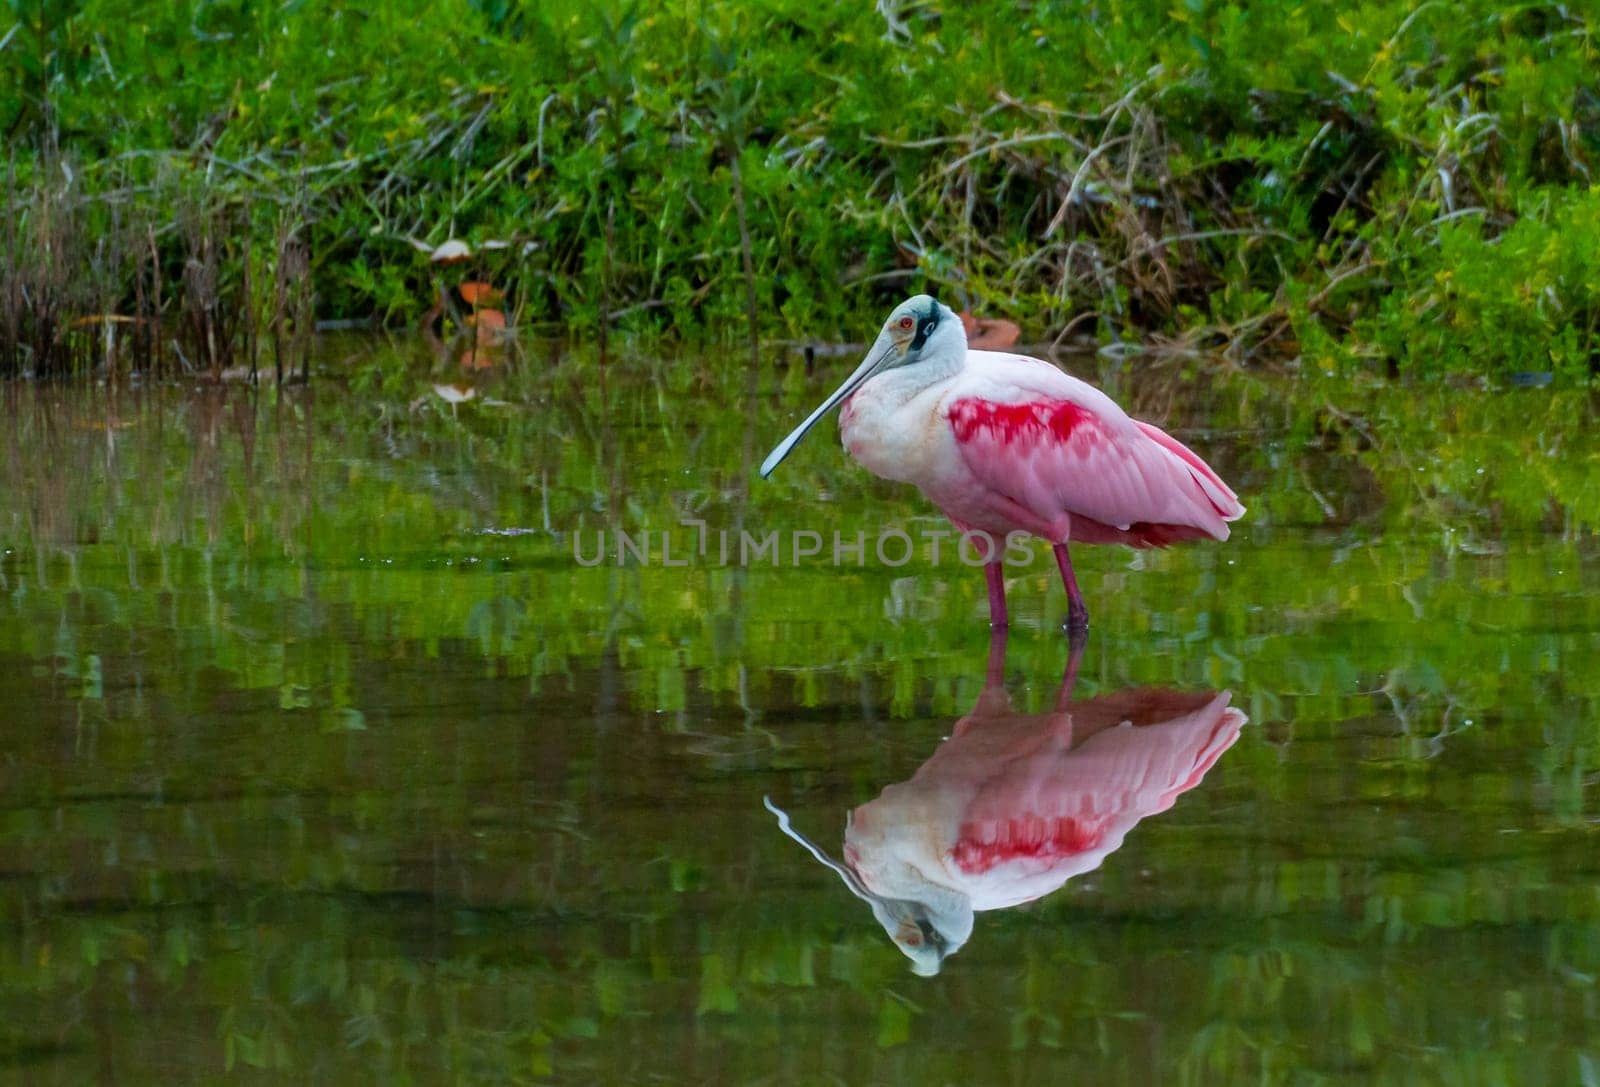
[763, 634, 1246, 977]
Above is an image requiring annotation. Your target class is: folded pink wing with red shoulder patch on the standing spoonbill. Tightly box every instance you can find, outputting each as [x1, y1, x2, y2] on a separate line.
[946, 355, 1245, 548]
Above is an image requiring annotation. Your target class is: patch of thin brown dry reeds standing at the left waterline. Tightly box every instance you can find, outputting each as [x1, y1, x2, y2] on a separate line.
[0, 157, 315, 381]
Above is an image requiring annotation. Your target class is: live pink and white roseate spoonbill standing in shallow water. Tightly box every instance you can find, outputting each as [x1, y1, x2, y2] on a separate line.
[762, 295, 1245, 632]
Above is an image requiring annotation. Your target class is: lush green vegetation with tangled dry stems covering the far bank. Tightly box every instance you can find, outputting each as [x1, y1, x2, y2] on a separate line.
[0, 0, 1600, 375]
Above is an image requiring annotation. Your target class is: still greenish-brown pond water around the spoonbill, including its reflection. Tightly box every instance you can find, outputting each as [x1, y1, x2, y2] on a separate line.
[0, 343, 1600, 1085]
